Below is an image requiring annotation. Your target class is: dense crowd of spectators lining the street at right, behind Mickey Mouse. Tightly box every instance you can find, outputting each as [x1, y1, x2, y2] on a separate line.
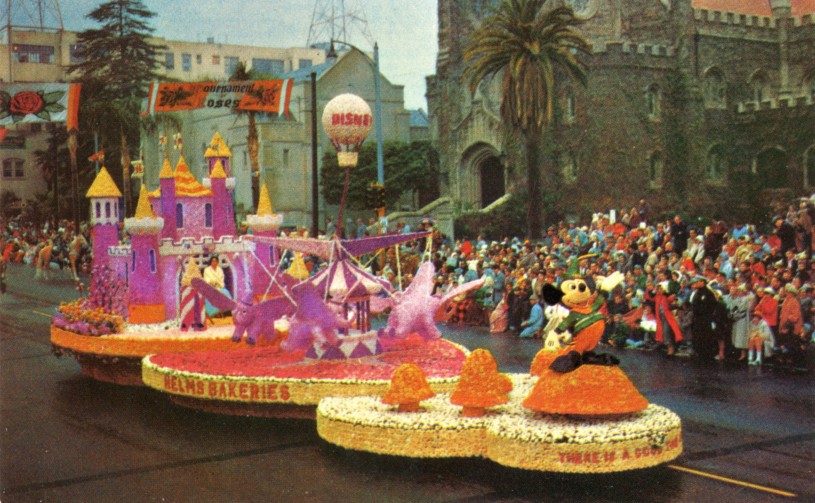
[424, 199, 815, 366]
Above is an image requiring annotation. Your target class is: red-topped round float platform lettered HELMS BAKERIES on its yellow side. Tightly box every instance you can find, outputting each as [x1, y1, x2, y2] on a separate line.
[142, 339, 467, 410]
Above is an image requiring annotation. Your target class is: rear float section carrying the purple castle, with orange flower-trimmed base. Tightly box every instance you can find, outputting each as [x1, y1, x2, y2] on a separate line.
[51, 133, 297, 385]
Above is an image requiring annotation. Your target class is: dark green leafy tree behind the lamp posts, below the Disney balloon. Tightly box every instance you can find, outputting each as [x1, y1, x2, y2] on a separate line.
[320, 141, 439, 210]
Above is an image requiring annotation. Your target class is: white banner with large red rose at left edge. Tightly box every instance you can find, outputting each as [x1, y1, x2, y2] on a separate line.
[0, 83, 80, 130]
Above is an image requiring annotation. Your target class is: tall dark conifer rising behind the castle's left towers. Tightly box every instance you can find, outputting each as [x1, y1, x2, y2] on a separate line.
[68, 0, 166, 215]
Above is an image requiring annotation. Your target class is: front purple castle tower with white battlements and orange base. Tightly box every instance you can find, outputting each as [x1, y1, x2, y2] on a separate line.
[125, 185, 165, 323]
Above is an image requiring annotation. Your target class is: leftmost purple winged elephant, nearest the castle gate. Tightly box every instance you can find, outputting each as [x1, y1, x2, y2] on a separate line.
[192, 278, 297, 344]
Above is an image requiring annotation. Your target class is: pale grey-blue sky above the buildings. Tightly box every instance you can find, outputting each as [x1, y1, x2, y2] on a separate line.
[60, 0, 438, 110]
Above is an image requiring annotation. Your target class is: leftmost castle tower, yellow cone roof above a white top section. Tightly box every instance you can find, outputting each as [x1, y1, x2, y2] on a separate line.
[85, 166, 122, 269]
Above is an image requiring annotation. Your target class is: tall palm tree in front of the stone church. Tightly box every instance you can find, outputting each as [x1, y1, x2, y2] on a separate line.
[463, 0, 590, 239]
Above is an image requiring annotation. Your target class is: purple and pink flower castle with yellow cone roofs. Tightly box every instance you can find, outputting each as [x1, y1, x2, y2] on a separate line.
[86, 133, 283, 323]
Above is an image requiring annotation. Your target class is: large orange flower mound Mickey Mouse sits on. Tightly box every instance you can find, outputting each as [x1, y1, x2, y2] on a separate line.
[523, 365, 648, 416]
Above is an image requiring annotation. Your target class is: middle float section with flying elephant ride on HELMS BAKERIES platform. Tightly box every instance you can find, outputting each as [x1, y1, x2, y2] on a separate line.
[143, 239, 483, 418]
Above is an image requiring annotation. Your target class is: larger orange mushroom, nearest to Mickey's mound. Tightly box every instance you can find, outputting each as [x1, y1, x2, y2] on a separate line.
[450, 349, 512, 417]
